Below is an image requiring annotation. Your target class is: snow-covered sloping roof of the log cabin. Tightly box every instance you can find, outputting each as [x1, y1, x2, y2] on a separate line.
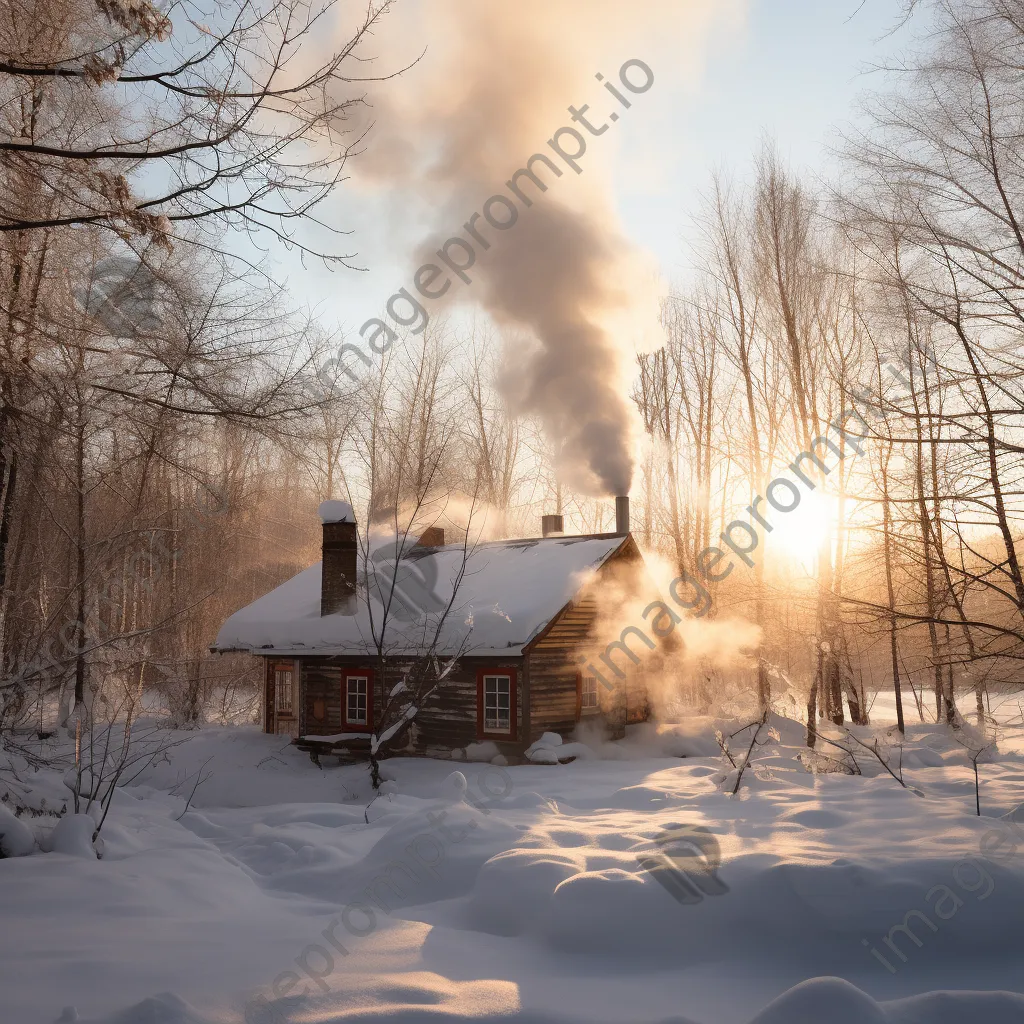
[212, 535, 627, 655]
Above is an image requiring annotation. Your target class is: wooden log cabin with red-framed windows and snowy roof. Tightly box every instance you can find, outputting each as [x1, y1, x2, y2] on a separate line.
[211, 498, 671, 761]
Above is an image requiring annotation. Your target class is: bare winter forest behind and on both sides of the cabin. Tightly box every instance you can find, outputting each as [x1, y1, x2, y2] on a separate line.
[0, 0, 1024, 741]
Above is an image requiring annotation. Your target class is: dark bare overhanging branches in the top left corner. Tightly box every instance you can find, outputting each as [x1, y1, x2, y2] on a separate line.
[0, 0, 390, 263]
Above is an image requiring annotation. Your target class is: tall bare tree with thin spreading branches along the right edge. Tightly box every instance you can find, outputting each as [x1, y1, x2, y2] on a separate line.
[846, 0, 1024, 696]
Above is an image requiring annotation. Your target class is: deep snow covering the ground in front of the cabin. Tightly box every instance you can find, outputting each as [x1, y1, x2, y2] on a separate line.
[0, 698, 1024, 1024]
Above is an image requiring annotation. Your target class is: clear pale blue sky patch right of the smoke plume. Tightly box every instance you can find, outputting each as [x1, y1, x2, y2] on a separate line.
[616, 0, 900, 278]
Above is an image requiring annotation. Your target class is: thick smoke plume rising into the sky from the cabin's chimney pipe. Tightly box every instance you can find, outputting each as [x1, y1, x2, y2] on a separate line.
[356, 0, 739, 496]
